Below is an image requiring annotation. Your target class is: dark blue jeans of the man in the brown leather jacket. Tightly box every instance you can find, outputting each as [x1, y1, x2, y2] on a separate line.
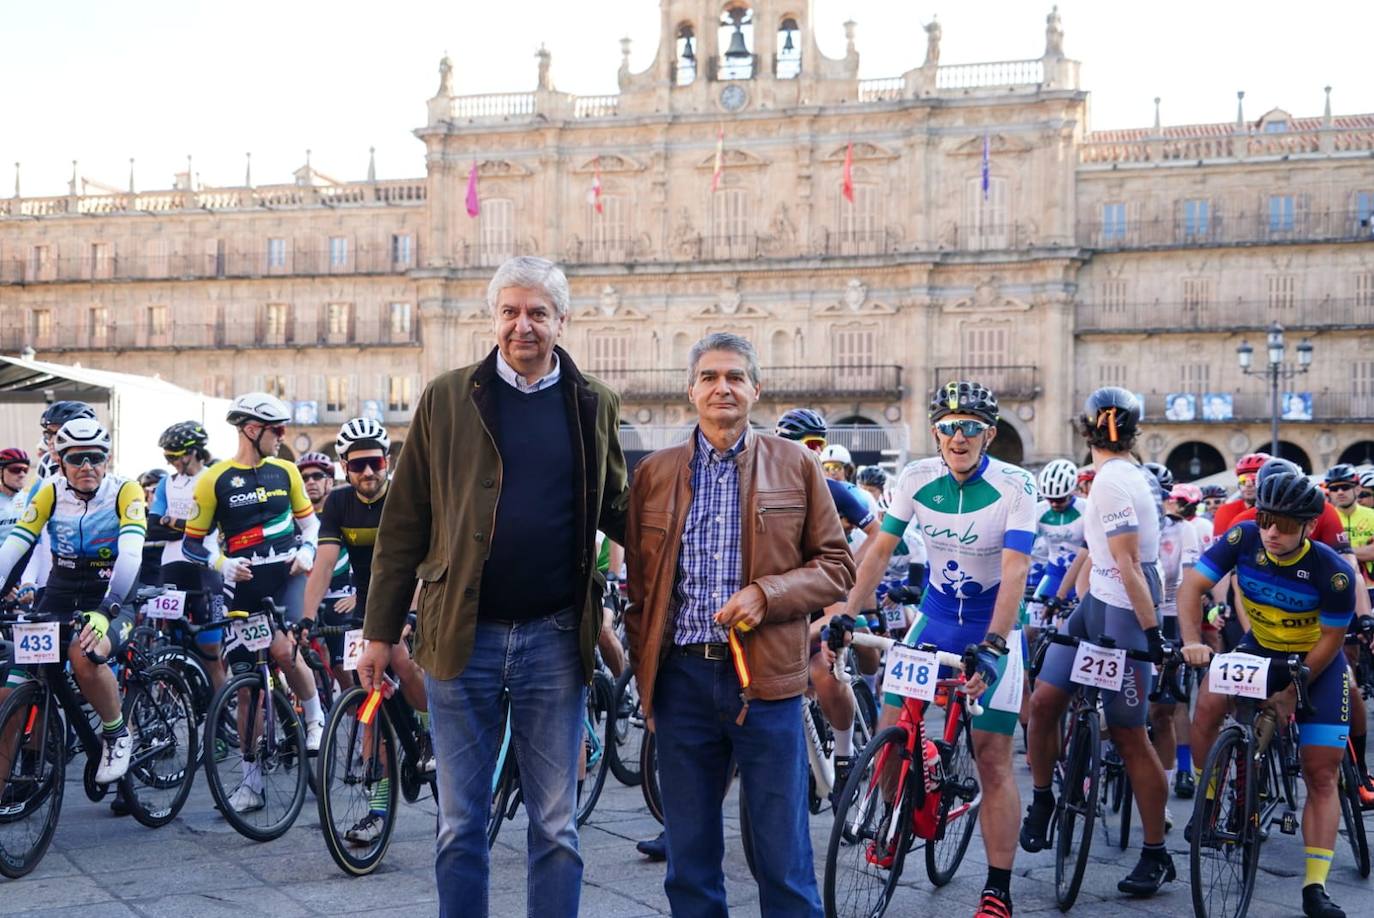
[654, 653, 820, 918]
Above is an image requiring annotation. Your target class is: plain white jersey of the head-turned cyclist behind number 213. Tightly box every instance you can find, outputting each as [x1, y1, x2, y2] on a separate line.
[1083, 459, 1160, 609]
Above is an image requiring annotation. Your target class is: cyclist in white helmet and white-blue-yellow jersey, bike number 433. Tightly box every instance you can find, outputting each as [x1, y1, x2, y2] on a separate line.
[0, 418, 147, 785]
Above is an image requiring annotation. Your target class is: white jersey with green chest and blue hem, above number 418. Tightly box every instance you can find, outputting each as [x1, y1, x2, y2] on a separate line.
[882, 456, 1036, 623]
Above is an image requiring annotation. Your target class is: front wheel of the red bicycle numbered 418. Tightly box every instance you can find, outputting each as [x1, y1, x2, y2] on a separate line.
[822, 727, 921, 918]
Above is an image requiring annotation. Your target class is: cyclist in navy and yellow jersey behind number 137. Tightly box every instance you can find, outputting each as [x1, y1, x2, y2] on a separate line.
[1179, 470, 1356, 918]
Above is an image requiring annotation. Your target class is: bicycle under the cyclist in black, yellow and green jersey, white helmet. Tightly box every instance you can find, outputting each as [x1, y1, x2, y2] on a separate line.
[203, 598, 311, 841]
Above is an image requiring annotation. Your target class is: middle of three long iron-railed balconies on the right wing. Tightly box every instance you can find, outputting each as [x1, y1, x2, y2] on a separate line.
[1074, 297, 1374, 334]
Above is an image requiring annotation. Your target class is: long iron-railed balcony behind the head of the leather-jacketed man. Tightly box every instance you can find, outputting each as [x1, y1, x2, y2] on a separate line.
[589, 366, 901, 401]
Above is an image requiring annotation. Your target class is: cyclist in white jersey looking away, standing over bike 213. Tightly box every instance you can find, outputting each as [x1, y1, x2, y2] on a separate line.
[1021, 386, 1176, 896]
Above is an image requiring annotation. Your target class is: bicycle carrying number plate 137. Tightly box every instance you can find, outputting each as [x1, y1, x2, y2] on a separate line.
[1189, 654, 1312, 918]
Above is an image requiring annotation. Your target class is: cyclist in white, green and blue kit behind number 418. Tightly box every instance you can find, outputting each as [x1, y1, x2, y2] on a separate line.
[826, 381, 1036, 918]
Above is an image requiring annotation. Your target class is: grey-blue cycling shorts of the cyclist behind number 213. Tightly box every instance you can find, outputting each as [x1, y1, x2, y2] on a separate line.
[1036, 592, 1154, 727]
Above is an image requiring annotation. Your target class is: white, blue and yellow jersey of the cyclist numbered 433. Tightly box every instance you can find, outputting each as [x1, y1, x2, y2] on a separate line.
[0, 475, 147, 605]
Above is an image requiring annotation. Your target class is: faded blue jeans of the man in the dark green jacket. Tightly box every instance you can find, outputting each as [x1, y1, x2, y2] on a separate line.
[425, 609, 587, 918]
